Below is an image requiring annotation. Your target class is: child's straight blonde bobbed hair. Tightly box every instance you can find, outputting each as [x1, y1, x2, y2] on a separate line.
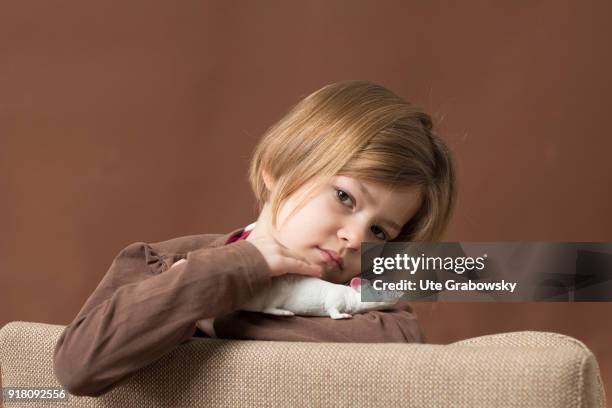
[249, 81, 457, 241]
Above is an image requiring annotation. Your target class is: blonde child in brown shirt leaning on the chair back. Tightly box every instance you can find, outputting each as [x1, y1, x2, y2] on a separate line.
[53, 81, 456, 396]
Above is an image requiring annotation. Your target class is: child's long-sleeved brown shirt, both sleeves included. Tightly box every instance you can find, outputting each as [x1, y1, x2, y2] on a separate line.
[53, 228, 424, 396]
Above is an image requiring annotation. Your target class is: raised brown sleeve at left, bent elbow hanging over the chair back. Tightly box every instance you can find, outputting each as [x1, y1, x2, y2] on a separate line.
[53, 241, 271, 396]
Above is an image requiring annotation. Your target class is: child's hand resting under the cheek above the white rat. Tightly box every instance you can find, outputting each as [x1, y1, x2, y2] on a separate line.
[247, 236, 323, 278]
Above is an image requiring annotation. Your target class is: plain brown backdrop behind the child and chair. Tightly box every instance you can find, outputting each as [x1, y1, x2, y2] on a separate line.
[0, 0, 612, 400]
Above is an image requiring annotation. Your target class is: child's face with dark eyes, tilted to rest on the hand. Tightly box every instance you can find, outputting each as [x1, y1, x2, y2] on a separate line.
[256, 176, 421, 283]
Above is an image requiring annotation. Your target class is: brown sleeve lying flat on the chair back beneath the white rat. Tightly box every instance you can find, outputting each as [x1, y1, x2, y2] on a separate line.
[215, 302, 426, 343]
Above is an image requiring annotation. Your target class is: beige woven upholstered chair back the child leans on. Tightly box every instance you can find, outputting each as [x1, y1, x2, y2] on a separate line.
[0, 322, 605, 408]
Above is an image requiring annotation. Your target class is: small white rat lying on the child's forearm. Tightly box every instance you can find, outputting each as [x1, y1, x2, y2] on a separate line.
[240, 274, 403, 319]
